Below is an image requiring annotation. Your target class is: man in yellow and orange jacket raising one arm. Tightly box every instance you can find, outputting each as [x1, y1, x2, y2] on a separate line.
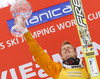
[19, 19, 89, 79]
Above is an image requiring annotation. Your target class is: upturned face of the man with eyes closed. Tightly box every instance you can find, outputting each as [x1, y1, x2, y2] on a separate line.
[61, 44, 77, 60]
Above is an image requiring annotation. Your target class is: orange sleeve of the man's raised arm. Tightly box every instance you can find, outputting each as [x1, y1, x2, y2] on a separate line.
[24, 32, 62, 79]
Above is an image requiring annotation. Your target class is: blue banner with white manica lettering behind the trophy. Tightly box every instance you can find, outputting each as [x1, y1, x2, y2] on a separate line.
[7, 1, 73, 30]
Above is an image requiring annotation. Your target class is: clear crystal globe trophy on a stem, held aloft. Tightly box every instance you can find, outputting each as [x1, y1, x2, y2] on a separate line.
[10, 0, 32, 37]
